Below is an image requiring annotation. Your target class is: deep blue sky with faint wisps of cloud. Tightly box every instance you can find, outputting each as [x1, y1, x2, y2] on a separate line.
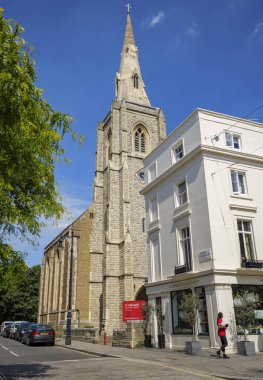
[1, 0, 263, 266]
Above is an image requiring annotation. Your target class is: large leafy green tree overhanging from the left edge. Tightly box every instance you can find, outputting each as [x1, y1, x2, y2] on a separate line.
[0, 8, 82, 256]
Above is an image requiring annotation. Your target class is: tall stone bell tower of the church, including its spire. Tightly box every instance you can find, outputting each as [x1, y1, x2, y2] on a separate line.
[90, 6, 166, 334]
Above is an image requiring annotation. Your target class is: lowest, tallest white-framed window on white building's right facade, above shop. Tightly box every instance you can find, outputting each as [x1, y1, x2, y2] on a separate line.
[237, 220, 255, 260]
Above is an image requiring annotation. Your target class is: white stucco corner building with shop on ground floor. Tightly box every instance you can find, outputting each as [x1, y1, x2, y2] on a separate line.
[141, 109, 263, 351]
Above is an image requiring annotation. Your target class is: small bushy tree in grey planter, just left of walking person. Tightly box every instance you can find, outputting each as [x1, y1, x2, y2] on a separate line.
[180, 293, 202, 341]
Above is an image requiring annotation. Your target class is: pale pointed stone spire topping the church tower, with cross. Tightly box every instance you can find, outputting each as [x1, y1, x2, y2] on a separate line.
[116, 4, 150, 106]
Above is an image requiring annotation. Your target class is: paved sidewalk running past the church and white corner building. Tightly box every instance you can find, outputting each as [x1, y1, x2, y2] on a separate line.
[56, 338, 263, 380]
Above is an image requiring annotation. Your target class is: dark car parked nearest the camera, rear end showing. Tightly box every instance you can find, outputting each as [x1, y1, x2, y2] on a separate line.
[22, 323, 55, 346]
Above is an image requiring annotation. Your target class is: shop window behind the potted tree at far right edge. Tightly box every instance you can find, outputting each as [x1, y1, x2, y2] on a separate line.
[232, 285, 263, 335]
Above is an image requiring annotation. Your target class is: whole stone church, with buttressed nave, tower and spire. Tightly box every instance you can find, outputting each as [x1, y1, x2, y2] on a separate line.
[38, 7, 166, 335]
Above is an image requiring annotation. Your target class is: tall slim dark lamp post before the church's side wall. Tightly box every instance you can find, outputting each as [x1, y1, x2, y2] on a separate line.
[59, 229, 79, 345]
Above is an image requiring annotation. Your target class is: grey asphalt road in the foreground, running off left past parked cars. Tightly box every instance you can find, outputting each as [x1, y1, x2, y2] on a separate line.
[0, 337, 223, 380]
